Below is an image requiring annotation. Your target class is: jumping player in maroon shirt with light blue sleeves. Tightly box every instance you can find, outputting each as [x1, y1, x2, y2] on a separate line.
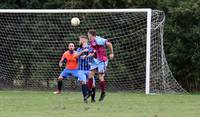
[85, 30, 114, 101]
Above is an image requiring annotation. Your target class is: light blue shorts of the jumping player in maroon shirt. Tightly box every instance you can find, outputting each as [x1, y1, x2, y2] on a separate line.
[90, 59, 108, 73]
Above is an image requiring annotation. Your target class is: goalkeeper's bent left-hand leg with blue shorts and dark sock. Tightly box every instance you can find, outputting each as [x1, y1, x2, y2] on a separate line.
[54, 69, 68, 94]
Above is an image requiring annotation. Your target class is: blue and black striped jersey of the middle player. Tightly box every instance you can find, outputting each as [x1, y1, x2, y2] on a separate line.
[77, 45, 93, 71]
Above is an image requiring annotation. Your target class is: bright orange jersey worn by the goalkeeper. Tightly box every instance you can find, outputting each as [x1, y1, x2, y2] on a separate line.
[61, 51, 78, 69]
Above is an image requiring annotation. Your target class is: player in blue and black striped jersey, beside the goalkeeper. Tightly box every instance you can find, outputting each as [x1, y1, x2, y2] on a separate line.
[77, 36, 95, 103]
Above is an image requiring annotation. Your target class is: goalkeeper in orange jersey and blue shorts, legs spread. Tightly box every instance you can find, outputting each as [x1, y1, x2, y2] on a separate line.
[54, 43, 88, 97]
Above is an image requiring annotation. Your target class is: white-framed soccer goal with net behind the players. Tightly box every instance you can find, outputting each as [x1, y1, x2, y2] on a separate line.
[0, 9, 185, 94]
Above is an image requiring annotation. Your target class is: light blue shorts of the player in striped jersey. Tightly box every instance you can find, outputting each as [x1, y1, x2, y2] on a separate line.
[78, 70, 95, 86]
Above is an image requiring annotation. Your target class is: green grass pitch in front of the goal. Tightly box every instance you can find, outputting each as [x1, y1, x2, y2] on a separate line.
[0, 91, 200, 117]
